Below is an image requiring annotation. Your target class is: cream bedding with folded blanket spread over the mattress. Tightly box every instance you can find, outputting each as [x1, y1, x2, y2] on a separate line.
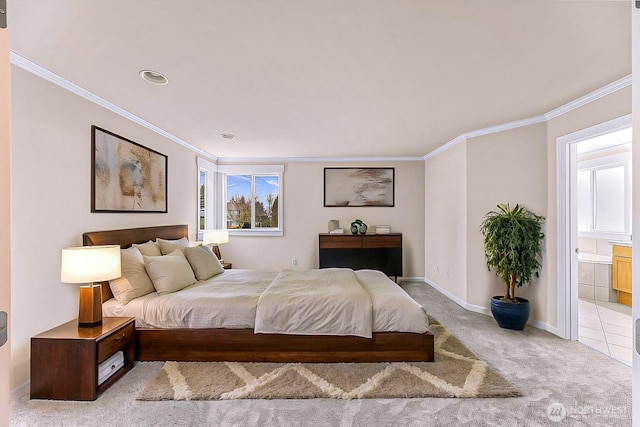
[102, 269, 429, 337]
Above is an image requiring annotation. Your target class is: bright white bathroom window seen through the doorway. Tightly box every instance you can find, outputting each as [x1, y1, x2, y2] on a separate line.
[577, 146, 631, 239]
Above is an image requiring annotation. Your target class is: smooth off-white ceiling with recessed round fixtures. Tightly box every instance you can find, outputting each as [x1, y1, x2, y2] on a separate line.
[8, 0, 631, 158]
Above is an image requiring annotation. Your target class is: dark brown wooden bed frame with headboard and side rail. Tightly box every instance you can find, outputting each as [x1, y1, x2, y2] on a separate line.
[82, 225, 434, 362]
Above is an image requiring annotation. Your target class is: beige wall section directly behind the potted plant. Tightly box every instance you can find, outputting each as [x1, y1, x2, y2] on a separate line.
[467, 123, 547, 321]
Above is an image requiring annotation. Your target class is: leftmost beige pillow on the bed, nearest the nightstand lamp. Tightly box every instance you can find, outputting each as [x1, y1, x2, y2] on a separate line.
[109, 247, 155, 305]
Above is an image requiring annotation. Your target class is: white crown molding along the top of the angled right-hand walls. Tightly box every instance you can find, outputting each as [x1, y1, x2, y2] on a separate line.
[423, 74, 631, 160]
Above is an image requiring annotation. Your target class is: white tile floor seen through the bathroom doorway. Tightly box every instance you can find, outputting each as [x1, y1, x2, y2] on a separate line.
[578, 298, 633, 366]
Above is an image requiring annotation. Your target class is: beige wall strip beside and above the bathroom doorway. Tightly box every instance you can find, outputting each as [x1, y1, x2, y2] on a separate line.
[546, 87, 631, 327]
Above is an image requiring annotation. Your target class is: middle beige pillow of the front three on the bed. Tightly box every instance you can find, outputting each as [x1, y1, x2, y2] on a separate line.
[143, 250, 196, 294]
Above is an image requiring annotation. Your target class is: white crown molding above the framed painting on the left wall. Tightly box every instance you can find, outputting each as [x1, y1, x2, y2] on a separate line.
[10, 50, 218, 161]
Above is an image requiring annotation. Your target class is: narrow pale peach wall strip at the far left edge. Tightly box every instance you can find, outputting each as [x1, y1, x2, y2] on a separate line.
[0, 29, 11, 425]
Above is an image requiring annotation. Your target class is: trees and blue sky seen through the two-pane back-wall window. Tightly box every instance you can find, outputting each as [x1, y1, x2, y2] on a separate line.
[227, 175, 280, 229]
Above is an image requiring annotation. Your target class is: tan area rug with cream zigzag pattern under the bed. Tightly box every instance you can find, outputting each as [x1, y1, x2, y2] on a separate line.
[137, 318, 521, 400]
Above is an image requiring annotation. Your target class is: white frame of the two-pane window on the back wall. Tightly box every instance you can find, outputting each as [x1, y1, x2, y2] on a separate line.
[218, 165, 284, 236]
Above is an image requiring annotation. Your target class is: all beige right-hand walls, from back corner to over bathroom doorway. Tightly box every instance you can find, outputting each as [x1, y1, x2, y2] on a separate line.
[425, 88, 631, 330]
